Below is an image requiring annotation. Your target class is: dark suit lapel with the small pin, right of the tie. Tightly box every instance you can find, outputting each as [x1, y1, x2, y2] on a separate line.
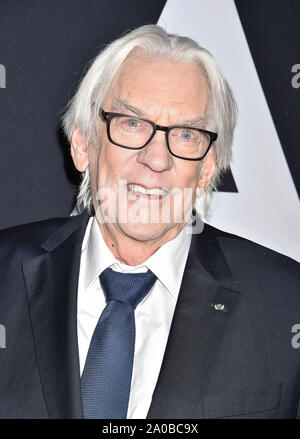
[148, 226, 239, 419]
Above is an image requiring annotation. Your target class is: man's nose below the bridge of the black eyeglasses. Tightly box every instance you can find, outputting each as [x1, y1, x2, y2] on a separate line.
[137, 131, 173, 172]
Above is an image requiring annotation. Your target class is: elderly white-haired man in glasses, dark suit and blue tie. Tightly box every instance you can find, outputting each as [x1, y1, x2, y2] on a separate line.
[0, 26, 300, 418]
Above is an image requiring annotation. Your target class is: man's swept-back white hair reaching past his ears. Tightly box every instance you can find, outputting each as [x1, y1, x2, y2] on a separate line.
[63, 25, 237, 216]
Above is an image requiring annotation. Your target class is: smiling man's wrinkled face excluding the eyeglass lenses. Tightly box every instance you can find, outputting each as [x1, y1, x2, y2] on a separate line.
[85, 54, 215, 245]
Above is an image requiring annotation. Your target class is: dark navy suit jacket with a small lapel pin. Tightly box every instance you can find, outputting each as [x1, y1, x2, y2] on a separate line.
[0, 214, 300, 419]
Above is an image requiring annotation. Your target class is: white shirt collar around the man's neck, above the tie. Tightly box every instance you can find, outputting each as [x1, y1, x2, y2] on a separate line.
[82, 217, 191, 299]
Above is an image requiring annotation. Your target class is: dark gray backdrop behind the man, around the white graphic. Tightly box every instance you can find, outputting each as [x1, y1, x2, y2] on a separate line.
[0, 0, 300, 228]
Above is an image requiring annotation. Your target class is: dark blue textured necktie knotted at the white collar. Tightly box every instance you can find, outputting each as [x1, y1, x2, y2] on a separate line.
[81, 268, 156, 419]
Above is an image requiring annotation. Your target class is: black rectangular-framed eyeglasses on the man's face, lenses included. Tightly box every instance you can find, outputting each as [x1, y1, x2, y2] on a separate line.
[99, 108, 218, 160]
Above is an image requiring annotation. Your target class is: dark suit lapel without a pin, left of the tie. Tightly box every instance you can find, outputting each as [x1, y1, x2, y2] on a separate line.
[23, 214, 88, 418]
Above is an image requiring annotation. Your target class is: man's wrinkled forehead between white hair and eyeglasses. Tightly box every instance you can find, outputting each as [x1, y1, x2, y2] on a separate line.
[105, 52, 209, 114]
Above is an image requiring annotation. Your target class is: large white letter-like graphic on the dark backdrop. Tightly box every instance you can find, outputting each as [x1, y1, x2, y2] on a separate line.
[158, 0, 300, 261]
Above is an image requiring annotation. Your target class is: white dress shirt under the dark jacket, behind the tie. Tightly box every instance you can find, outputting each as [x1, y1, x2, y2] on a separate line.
[77, 217, 191, 419]
